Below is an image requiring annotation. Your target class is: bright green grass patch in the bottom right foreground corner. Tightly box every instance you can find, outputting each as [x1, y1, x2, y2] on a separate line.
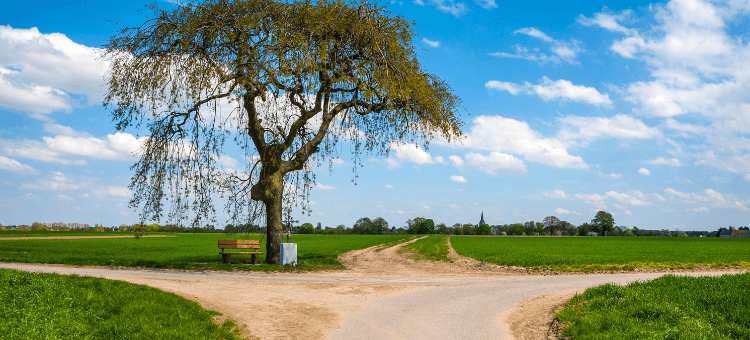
[557, 273, 750, 340]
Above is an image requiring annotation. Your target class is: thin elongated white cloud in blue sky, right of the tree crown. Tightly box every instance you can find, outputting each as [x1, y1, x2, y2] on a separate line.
[484, 77, 612, 106]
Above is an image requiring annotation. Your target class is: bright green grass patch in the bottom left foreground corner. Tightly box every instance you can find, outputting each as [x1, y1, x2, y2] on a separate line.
[0, 269, 240, 340]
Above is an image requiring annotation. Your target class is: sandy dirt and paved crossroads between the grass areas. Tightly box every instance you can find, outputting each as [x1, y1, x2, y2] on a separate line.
[0, 236, 744, 339]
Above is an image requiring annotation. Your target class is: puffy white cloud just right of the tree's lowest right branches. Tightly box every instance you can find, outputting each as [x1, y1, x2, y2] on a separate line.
[460, 116, 588, 169]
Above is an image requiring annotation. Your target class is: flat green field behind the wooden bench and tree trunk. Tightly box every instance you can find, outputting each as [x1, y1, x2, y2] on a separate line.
[0, 234, 409, 271]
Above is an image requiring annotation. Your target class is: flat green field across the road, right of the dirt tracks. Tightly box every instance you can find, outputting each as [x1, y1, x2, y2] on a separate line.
[450, 236, 750, 272]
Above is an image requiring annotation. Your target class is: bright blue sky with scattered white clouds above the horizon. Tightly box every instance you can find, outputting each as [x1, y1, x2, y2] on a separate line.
[0, 0, 750, 230]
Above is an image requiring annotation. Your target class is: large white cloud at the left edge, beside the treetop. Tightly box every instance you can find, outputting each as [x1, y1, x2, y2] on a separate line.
[0, 25, 108, 115]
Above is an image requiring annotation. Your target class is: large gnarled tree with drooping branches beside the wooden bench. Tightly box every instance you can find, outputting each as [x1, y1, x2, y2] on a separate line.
[104, 0, 461, 263]
